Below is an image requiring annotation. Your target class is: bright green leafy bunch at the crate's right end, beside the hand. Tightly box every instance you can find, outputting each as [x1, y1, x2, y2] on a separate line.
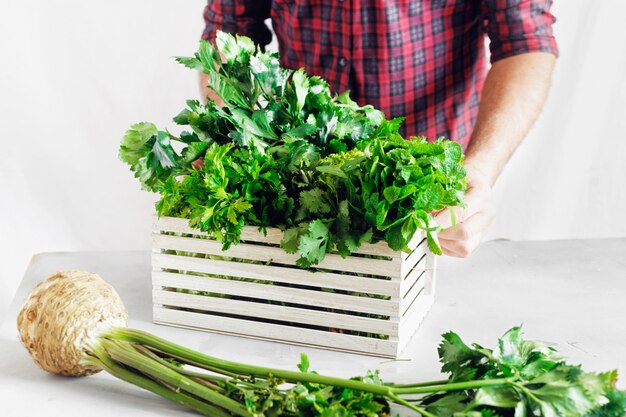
[283, 130, 465, 261]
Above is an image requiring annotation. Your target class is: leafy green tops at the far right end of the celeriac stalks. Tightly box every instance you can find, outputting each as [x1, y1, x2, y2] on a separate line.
[420, 327, 626, 417]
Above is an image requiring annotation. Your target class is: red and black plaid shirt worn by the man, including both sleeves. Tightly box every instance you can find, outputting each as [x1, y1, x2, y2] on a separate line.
[202, 0, 557, 147]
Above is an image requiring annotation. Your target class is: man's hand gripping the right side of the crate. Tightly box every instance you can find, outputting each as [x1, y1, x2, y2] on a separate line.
[435, 164, 495, 258]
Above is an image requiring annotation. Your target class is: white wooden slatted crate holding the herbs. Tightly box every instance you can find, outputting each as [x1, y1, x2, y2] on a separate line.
[152, 216, 435, 358]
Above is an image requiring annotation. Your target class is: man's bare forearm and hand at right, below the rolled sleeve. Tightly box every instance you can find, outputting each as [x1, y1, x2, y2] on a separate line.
[436, 52, 556, 257]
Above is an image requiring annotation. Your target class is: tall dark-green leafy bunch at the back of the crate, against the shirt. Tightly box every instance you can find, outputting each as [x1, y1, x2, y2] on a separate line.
[175, 32, 384, 151]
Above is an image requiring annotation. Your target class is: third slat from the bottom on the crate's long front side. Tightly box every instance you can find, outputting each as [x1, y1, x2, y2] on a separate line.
[152, 271, 399, 317]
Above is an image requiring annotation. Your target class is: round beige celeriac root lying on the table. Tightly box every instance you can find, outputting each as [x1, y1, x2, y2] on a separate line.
[17, 270, 128, 376]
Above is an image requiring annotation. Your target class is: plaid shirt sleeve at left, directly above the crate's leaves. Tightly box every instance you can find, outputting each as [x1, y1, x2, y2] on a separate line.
[202, 0, 272, 47]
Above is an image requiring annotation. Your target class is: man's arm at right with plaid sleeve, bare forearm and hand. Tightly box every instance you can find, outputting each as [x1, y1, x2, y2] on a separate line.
[436, 0, 558, 257]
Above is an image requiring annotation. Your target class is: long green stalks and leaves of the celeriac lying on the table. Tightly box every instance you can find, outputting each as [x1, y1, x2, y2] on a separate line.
[100, 327, 626, 417]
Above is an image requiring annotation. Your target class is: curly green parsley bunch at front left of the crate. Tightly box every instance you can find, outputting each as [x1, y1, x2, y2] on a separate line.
[157, 143, 294, 249]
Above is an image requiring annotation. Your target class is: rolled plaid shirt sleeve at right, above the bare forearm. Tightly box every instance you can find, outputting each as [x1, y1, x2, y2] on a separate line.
[482, 0, 558, 62]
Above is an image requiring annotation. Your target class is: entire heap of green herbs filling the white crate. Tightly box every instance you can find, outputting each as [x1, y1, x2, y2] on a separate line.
[120, 32, 466, 267]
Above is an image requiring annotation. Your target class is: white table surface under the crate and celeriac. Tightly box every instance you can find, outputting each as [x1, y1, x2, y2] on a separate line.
[0, 239, 626, 417]
